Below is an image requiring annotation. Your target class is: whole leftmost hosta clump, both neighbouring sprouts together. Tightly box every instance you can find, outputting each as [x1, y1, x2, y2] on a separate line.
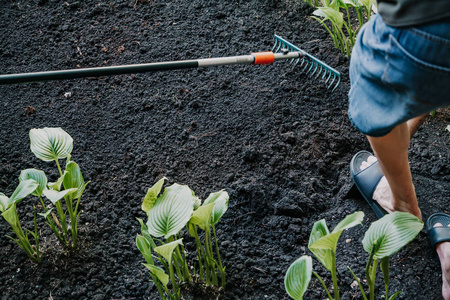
[0, 128, 89, 262]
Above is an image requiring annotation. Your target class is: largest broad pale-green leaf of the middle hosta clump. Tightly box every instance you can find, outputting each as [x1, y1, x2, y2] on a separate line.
[147, 183, 194, 239]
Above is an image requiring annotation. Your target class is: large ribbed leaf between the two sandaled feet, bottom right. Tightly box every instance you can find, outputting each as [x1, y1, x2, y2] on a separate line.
[362, 212, 423, 259]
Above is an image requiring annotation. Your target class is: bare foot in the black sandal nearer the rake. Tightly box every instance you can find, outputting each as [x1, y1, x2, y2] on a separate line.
[360, 156, 422, 219]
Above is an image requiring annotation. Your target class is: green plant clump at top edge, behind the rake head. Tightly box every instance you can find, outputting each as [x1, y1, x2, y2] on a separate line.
[304, 0, 375, 57]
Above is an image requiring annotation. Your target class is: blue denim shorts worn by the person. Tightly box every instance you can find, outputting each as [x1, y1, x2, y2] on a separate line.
[348, 15, 450, 137]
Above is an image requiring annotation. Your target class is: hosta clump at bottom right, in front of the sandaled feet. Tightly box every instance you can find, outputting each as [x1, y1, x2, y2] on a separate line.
[284, 212, 423, 300]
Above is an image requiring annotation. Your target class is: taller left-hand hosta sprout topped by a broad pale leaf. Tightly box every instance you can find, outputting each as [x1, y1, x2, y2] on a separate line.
[30, 128, 89, 248]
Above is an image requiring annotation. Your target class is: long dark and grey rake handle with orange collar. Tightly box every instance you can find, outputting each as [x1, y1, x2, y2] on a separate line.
[0, 51, 303, 85]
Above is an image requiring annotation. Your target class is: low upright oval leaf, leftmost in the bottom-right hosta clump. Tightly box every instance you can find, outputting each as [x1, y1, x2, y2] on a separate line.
[284, 255, 312, 300]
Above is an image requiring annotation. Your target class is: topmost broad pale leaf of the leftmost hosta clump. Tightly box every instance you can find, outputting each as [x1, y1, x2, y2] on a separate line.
[30, 127, 73, 161]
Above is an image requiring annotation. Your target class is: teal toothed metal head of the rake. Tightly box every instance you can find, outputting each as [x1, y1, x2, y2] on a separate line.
[272, 34, 341, 91]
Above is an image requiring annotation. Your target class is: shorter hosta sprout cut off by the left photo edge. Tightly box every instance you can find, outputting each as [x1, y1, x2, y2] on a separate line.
[0, 179, 41, 263]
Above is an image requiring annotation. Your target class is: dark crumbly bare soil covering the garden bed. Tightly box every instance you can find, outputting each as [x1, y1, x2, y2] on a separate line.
[0, 0, 450, 300]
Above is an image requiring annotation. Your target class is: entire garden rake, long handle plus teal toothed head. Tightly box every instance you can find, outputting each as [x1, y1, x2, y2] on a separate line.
[0, 35, 341, 91]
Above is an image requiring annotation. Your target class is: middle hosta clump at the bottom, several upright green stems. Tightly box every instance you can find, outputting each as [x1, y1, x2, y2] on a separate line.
[136, 178, 229, 299]
